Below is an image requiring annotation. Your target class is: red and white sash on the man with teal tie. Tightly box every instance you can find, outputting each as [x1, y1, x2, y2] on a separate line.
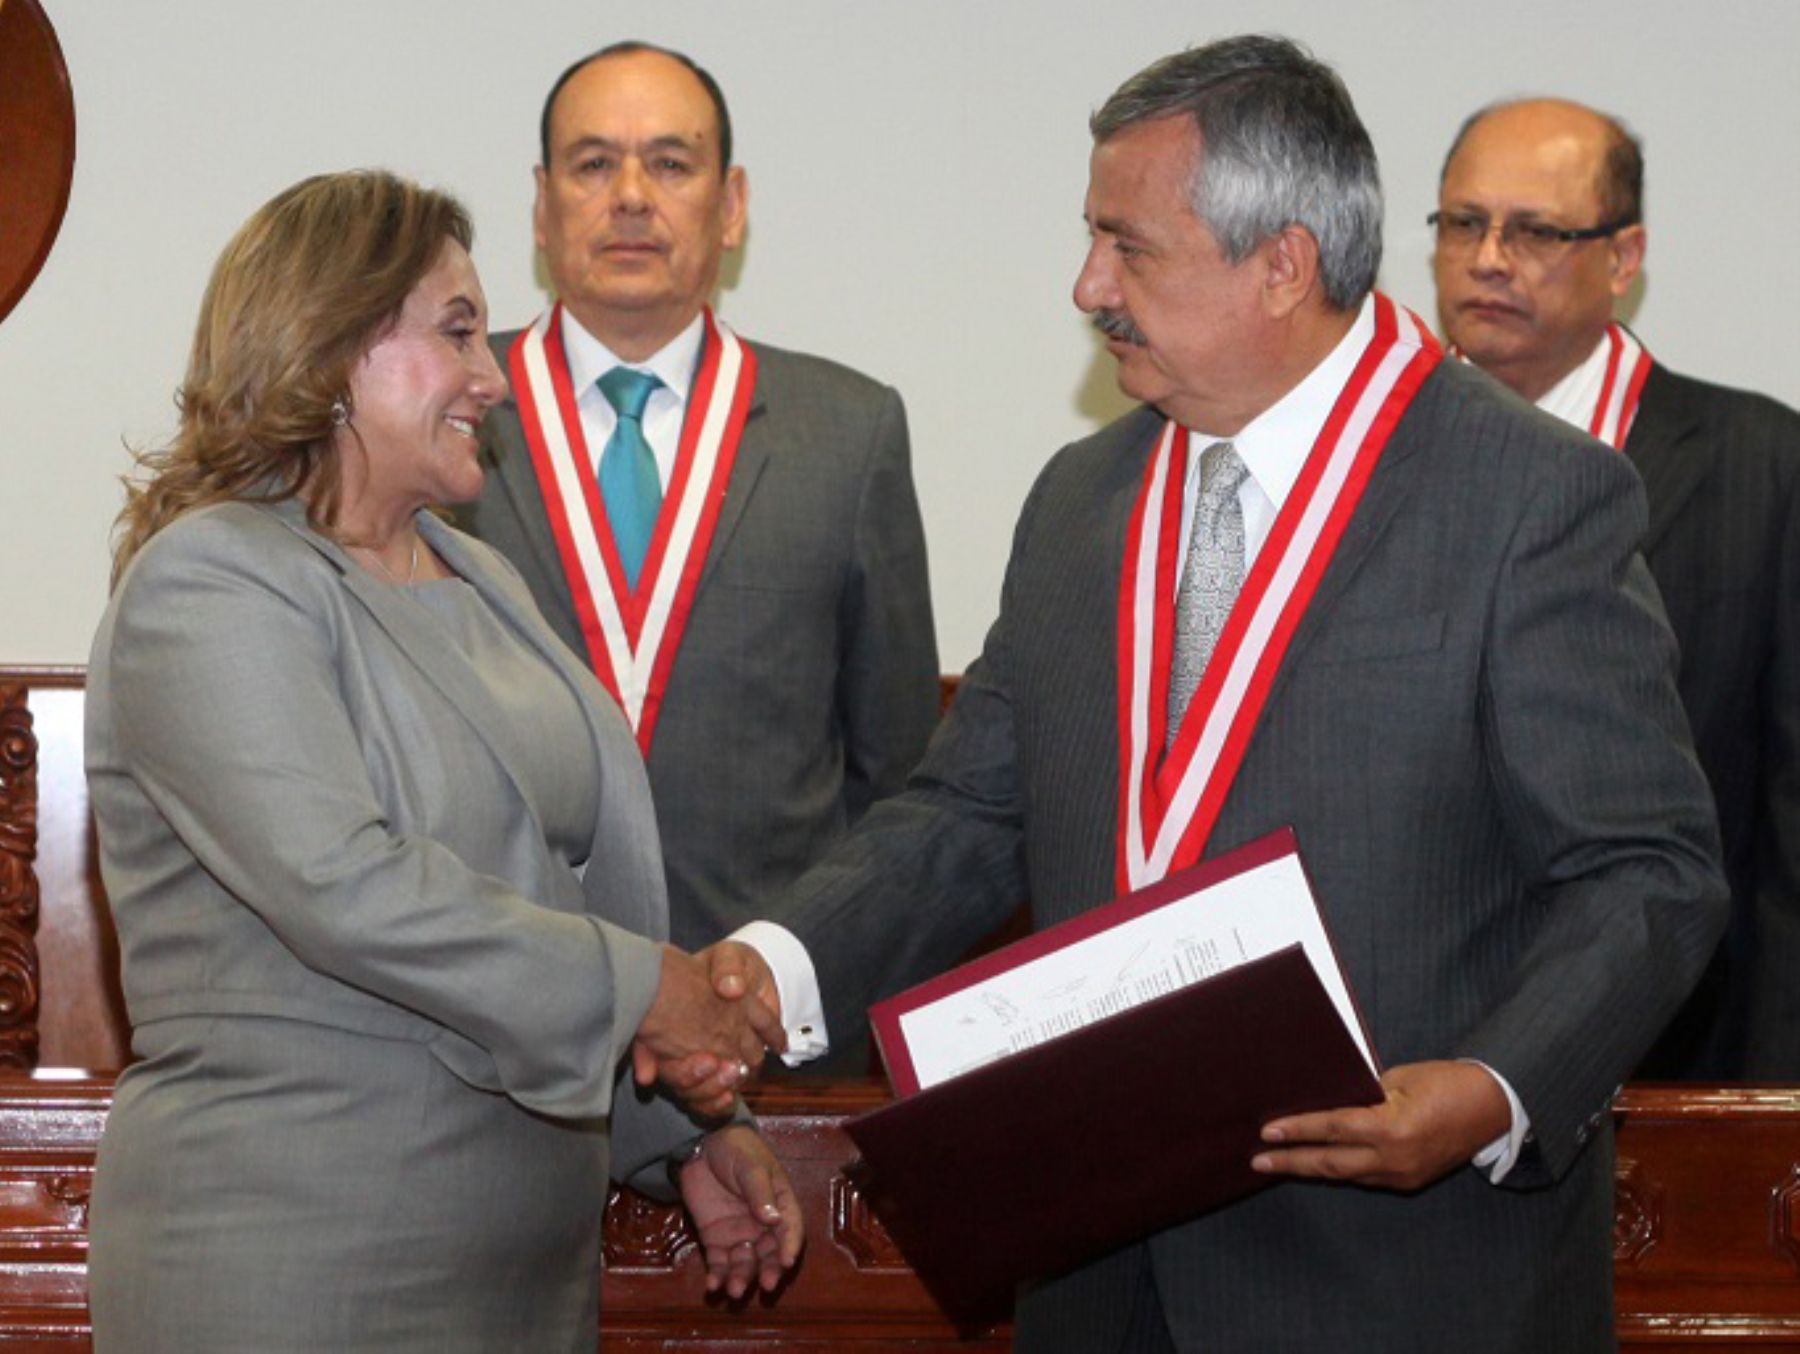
[508, 304, 756, 756]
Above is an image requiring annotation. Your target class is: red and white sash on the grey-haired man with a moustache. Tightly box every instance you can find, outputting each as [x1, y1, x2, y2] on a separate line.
[1118, 293, 1444, 893]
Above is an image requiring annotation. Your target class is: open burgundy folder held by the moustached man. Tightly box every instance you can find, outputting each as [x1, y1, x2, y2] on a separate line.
[846, 830, 1382, 1322]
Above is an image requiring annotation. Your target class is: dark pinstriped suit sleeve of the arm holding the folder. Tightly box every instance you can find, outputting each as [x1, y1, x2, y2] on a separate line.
[1456, 450, 1726, 1187]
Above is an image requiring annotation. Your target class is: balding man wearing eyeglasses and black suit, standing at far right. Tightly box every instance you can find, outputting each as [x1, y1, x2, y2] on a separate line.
[1429, 99, 1800, 1080]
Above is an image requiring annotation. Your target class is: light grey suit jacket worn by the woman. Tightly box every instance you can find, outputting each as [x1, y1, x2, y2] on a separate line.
[86, 502, 693, 1174]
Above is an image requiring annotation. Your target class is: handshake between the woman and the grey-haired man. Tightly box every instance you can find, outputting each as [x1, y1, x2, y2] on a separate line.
[632, 940, 787, 1115]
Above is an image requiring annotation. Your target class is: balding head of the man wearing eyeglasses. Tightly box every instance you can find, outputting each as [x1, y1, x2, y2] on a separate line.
[1433, 99, 1645, 400]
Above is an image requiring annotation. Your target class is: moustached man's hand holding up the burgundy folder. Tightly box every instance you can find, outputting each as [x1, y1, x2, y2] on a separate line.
[1251, 1062, 1512, 1190]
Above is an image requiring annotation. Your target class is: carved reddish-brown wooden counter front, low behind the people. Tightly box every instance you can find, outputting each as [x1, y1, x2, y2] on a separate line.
[0, 1073, 1800, 1354]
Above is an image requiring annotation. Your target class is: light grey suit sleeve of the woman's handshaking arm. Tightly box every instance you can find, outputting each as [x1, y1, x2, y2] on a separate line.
[106, 524, 659, 1116]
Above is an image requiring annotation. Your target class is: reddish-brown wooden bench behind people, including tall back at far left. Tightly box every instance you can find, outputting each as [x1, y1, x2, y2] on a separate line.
[0, 668, 1800, 1354]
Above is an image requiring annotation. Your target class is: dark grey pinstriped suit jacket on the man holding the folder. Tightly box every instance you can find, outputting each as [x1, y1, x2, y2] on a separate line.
[787, 362, 1724, 1354]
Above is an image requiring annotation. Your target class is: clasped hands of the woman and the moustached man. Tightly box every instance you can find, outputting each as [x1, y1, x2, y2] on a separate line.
[632, 945, 787, 1115]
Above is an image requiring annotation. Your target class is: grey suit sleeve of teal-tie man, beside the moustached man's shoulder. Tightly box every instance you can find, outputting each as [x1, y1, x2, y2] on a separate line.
[837, 389, 938, 823]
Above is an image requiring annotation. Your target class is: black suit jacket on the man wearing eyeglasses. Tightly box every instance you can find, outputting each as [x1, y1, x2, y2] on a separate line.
[1625, 367, 1800, 1080]
